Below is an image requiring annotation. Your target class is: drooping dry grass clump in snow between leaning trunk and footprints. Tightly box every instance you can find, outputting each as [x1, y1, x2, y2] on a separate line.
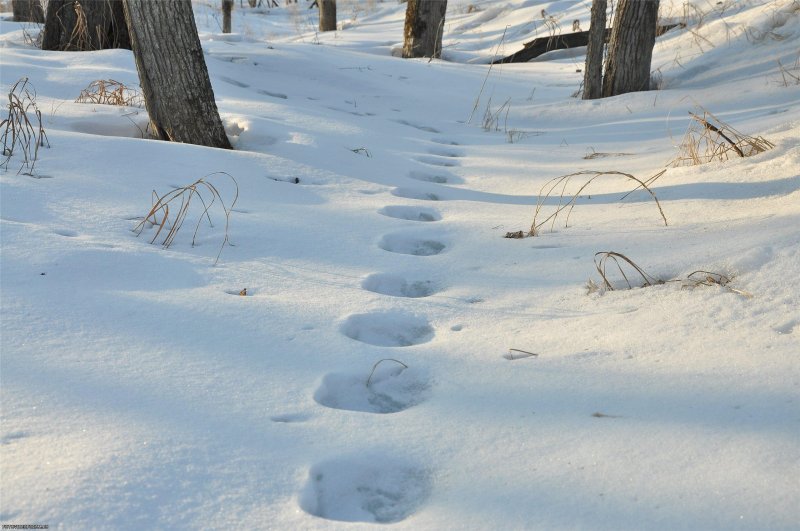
[133, 172, 239, 265]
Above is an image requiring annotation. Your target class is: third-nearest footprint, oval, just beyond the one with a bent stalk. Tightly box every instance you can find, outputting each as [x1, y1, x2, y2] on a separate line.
[340, 311, 435, 347]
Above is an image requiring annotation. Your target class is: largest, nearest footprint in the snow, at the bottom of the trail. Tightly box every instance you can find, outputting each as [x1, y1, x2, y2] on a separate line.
[299, 452, 431, 524]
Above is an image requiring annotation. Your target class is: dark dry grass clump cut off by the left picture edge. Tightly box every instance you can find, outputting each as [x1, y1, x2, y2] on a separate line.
[0, 77, 50, 176]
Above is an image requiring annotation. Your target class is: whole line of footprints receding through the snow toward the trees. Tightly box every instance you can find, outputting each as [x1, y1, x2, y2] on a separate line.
[299, 128, 463, 523]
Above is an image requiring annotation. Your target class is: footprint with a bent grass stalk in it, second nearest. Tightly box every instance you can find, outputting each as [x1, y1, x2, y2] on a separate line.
[314, 359, 430, 414]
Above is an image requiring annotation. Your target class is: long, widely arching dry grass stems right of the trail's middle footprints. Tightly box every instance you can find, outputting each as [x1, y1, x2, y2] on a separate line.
[528, 170, 667, 236]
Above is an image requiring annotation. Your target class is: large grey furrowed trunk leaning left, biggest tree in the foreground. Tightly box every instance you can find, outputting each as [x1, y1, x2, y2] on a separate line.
[124, 0, 231, 149]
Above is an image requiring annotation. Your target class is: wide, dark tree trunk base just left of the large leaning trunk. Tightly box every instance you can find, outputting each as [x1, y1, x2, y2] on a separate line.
[42, 0, 131, 51]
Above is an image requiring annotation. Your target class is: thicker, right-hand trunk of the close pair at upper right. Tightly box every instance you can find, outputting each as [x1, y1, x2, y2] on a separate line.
[603, 0, 658, 97]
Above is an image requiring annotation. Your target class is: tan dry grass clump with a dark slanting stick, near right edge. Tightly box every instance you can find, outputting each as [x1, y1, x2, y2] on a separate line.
[671, 107, 775, 167]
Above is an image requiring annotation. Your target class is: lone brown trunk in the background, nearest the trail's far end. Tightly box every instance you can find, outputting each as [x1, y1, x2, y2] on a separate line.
[403, 0, 447, 58]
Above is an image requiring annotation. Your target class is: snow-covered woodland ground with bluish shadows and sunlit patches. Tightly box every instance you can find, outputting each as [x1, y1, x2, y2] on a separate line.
[0, 0, 800, 530]
